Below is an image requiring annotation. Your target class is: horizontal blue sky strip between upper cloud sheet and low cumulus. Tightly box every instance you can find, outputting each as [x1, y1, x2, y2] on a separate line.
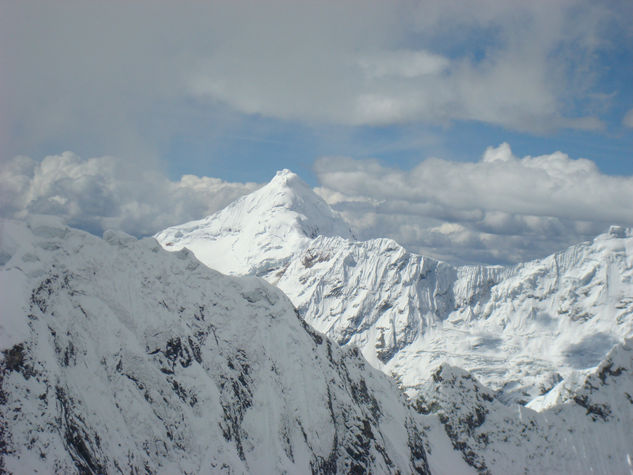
[166, 118, 633, 186]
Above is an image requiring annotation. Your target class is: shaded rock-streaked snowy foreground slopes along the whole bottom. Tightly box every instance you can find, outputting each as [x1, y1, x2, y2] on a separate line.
[0, 219, 633, 474]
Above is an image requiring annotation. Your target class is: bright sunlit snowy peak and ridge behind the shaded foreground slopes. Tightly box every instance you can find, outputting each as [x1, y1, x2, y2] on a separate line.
[157, 171, 633, 403]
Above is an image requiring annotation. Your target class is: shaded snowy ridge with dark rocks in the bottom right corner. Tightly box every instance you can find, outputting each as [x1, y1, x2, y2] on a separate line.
[415, 340, 633, 474]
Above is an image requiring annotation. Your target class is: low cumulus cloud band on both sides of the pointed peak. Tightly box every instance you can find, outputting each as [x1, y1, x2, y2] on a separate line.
[0, 143, 633, 263]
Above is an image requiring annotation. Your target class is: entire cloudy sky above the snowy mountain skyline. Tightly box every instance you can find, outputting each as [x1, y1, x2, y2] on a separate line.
[0, 0, 633, 262]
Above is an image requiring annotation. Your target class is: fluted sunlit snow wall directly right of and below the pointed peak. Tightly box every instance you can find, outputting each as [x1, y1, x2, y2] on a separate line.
[277, 237, 456, 366]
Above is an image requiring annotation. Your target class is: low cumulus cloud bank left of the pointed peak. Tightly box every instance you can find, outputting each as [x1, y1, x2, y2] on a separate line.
[0, 152, 258, 236]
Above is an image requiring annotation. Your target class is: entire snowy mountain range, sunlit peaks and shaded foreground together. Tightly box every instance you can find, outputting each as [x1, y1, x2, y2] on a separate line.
[0, 170, 633, 474]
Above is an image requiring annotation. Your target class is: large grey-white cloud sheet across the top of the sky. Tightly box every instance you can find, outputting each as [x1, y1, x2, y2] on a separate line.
[0, 0, 626, 161]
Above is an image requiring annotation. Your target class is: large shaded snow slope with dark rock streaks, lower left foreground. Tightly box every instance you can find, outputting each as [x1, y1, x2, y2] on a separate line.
[0, 221, 434, 473]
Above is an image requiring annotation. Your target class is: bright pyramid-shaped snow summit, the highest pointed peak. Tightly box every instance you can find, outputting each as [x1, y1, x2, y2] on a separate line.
[155, 170, 352, 279]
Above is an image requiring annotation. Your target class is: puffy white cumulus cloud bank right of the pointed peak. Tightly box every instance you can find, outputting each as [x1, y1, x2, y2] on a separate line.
[315, 143, 633, 263]
